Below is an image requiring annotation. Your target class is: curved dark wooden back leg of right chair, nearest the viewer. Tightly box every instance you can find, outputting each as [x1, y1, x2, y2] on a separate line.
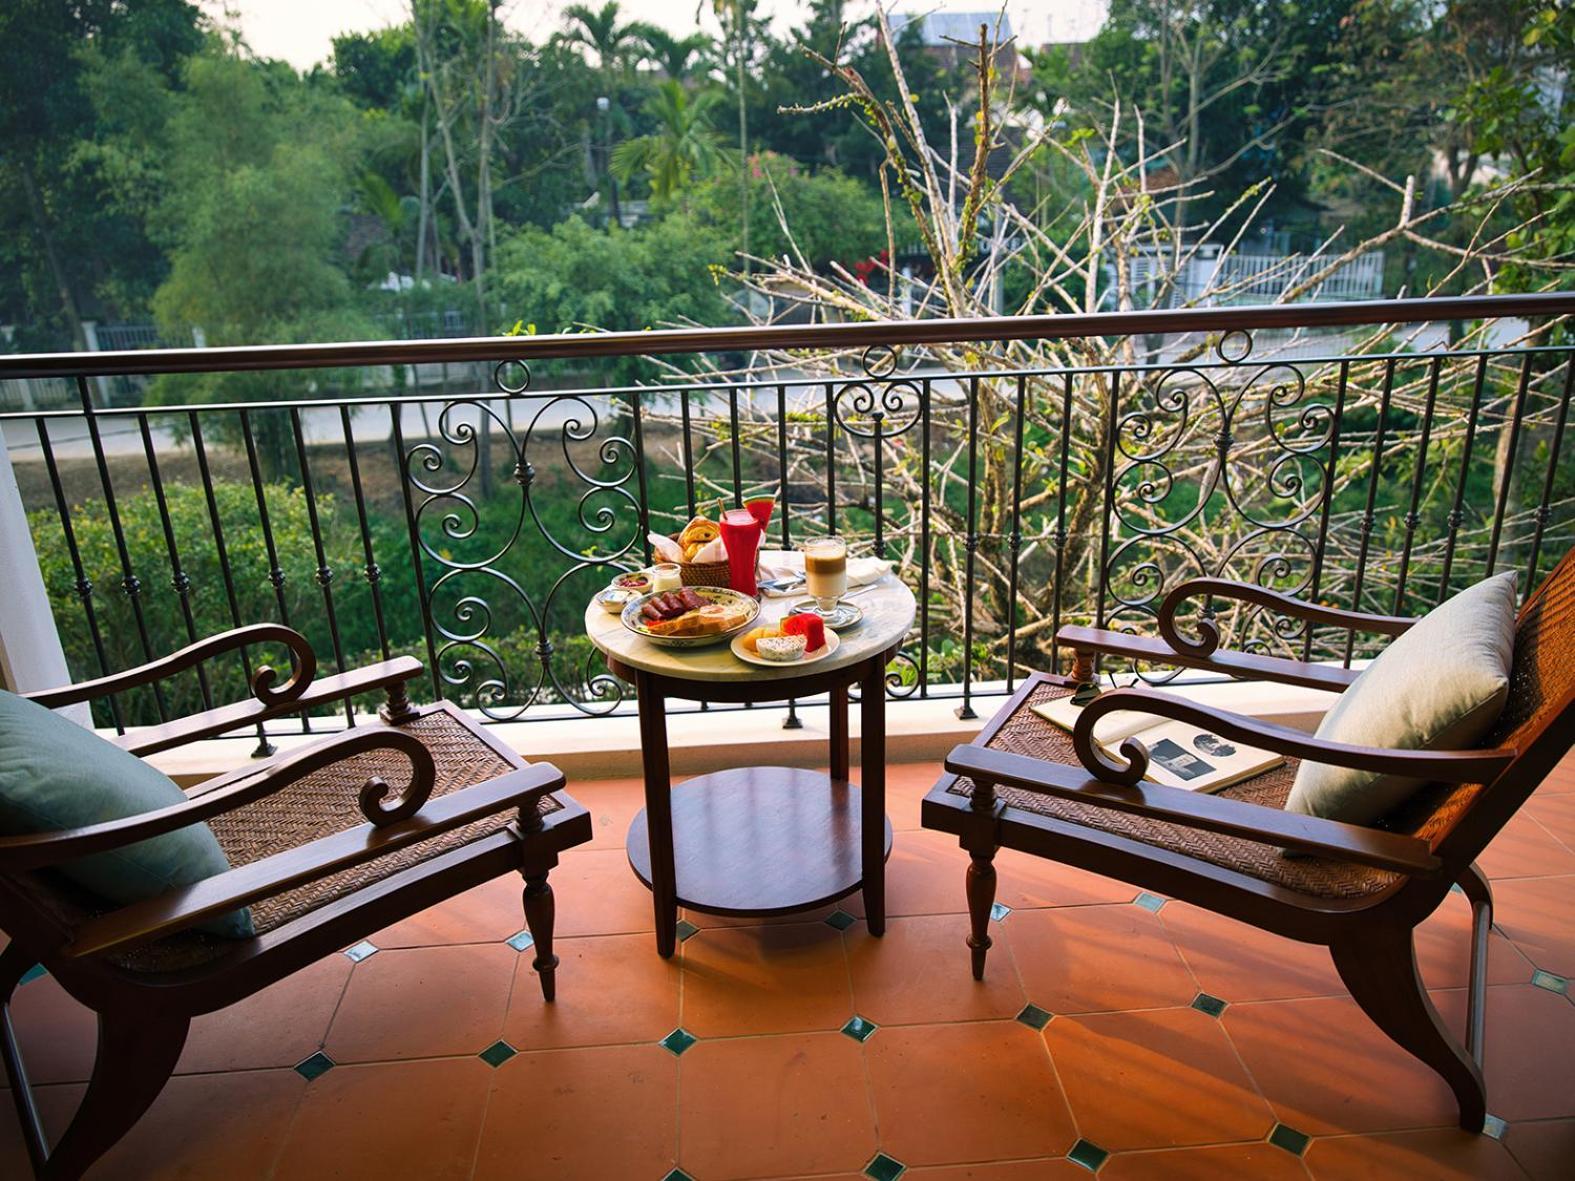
[1329, 929, 1487, 1132]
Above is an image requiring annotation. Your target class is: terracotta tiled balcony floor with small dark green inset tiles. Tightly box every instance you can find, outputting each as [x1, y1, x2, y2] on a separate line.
[0, 761, 1575, 1181]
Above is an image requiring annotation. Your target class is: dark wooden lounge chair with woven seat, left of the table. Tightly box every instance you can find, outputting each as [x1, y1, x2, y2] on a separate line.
[0, 625, 591, 1181]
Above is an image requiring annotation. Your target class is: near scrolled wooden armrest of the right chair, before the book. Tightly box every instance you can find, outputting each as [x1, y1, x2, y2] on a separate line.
[1073, 688, 1515, 784]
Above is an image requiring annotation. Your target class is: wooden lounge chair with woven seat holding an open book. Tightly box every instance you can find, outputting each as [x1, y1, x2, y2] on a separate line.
[923, 551, 1575, 1132]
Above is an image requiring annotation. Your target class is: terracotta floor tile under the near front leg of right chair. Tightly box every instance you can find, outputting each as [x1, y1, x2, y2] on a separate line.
[847, 915, 1027, 1025]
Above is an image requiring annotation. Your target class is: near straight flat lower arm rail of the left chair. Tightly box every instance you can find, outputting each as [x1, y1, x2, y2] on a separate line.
[65, 758, 564, 957]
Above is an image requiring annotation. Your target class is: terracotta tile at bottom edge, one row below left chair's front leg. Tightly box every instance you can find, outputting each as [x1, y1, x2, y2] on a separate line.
[476, 1046, 679, 1181]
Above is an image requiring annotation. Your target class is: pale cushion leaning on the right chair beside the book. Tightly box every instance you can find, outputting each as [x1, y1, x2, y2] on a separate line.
[1285, 573, 1515, 824]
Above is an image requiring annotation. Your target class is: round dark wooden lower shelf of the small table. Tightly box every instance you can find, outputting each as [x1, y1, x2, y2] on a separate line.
[627, 767, 891, 915]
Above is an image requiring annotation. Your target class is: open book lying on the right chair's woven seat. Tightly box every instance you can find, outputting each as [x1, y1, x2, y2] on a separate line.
[1033, 698, 1285, 792]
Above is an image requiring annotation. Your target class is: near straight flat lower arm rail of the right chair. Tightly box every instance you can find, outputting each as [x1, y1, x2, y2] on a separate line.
[945, 745, 1443, 877]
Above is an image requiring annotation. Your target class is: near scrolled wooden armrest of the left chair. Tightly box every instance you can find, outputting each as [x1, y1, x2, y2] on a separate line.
[0, 726, 436, 872]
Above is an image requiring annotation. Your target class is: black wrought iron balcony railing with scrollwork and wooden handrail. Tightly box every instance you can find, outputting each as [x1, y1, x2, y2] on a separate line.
[0, 294, 1575, 740]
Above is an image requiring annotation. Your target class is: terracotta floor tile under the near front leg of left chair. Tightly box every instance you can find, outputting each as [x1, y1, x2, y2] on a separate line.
[502, 935, 679, 1050]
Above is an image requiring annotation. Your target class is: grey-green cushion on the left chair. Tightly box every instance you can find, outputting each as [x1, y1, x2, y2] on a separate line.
[0, 690, 254, 939]
